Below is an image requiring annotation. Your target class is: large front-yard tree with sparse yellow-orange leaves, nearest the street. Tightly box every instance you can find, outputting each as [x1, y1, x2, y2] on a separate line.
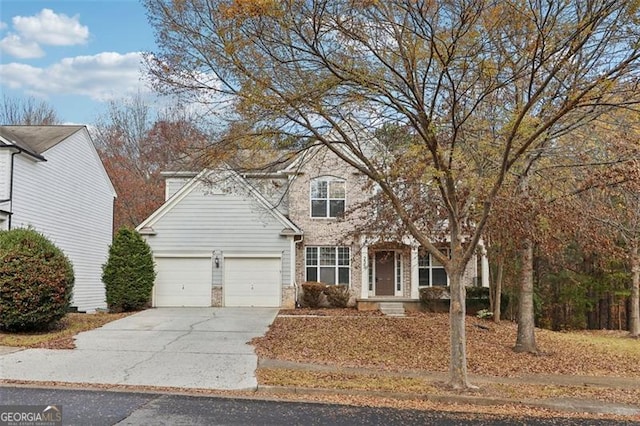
[145, 0, 640, 388]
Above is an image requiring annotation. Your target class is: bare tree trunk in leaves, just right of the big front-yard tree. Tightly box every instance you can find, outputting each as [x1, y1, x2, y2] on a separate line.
[514, 239, 538, 353]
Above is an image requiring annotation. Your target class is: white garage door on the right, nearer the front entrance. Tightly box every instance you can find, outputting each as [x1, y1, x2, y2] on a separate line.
[224, 258, 282, 307]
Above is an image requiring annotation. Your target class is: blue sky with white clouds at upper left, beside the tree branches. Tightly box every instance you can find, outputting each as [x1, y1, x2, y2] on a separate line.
[0, 0, 156, 124]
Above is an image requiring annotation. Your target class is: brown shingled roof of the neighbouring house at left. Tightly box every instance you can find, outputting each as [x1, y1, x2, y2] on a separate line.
[0, 126, 84, 160]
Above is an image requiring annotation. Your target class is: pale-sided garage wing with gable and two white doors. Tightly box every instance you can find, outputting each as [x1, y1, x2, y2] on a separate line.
[137, 170, 302, 307]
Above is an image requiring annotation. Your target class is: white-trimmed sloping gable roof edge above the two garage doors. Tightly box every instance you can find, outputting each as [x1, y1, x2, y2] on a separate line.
[136, 166, 302, 235]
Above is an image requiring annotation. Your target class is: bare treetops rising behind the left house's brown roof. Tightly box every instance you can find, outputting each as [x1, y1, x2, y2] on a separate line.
[0, 95, 60, 125]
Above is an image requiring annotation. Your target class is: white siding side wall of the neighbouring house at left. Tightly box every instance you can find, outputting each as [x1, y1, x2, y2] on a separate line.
[12, 131, 114, 311]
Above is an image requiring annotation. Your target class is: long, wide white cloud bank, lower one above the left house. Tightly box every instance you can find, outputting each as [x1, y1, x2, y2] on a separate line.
[0, 52, 150, 101]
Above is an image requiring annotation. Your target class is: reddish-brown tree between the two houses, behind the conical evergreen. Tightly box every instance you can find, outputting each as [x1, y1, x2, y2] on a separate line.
[93, 95, 205, 229]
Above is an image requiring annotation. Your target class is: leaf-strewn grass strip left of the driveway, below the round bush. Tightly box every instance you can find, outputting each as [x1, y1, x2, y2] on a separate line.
[0, 312, 129, 349]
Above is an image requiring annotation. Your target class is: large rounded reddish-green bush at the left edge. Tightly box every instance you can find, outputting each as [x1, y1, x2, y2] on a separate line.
[0, 229, 74, 331]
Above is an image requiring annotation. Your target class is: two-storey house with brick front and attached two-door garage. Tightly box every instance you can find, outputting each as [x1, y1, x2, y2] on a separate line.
[137, 144, 488, 308]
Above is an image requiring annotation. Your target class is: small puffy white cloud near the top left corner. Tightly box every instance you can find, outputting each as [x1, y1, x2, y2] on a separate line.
[0, 9, 89, 58]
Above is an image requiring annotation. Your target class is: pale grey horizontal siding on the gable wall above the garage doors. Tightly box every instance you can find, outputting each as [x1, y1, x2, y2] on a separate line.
[147, 183, 292, 286]
